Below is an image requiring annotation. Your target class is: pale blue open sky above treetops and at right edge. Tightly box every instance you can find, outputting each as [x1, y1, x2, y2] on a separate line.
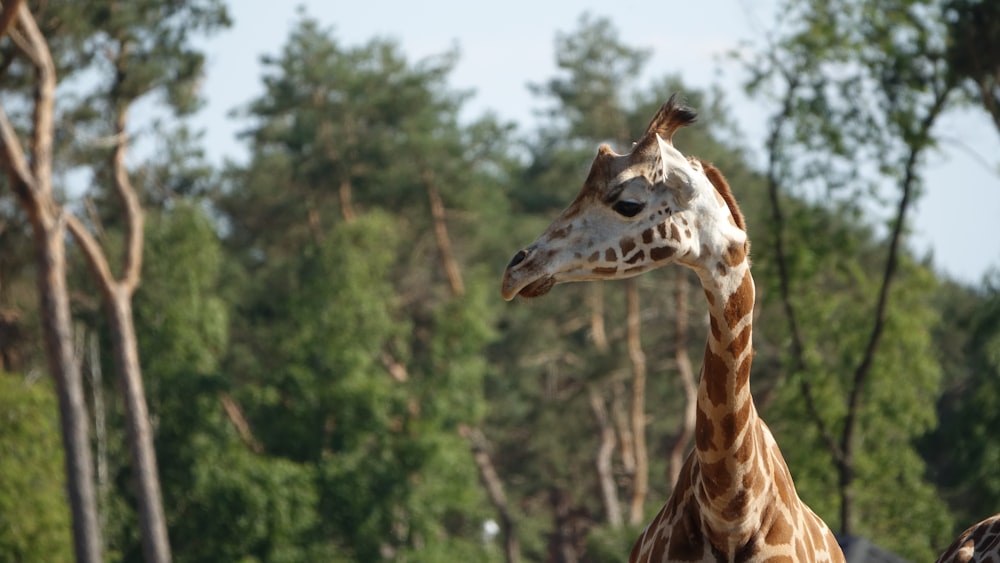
[188, 0, 1000, 284]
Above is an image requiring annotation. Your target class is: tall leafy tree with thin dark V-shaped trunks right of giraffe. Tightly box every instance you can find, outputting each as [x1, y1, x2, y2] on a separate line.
[747, 0, 972, 560]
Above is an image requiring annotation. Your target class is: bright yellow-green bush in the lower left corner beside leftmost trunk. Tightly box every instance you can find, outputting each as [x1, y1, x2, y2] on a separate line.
[0, 372, 73, 562]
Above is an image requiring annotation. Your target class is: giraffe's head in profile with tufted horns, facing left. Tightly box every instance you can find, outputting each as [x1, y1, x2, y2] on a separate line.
[501, 96, 748, 300]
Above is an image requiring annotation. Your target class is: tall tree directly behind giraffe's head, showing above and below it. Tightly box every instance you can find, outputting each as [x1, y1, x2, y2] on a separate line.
[490, 12, 772, 561]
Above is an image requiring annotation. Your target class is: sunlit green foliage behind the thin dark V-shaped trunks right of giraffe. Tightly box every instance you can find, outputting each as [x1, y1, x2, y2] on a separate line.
[756, 198, 952, 560]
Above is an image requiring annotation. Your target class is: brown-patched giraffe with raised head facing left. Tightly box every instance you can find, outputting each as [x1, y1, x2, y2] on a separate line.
[501, 95, 844, 563]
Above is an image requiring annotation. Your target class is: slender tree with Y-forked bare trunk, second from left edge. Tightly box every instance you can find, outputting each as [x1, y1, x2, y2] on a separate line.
[68, 4, 229, 561]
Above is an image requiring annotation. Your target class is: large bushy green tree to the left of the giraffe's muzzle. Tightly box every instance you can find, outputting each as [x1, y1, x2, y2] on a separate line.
[215, 17, 507, 560]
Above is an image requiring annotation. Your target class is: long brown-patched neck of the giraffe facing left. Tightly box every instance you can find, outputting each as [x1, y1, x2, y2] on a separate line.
[694, 255, 769, 538]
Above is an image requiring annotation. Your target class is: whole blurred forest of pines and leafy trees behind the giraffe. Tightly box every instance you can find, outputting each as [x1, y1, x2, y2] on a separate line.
[0, 0, 1000, 561]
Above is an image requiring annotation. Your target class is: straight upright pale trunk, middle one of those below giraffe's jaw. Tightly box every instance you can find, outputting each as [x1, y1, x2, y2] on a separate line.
[625, 279, 649, 525]
